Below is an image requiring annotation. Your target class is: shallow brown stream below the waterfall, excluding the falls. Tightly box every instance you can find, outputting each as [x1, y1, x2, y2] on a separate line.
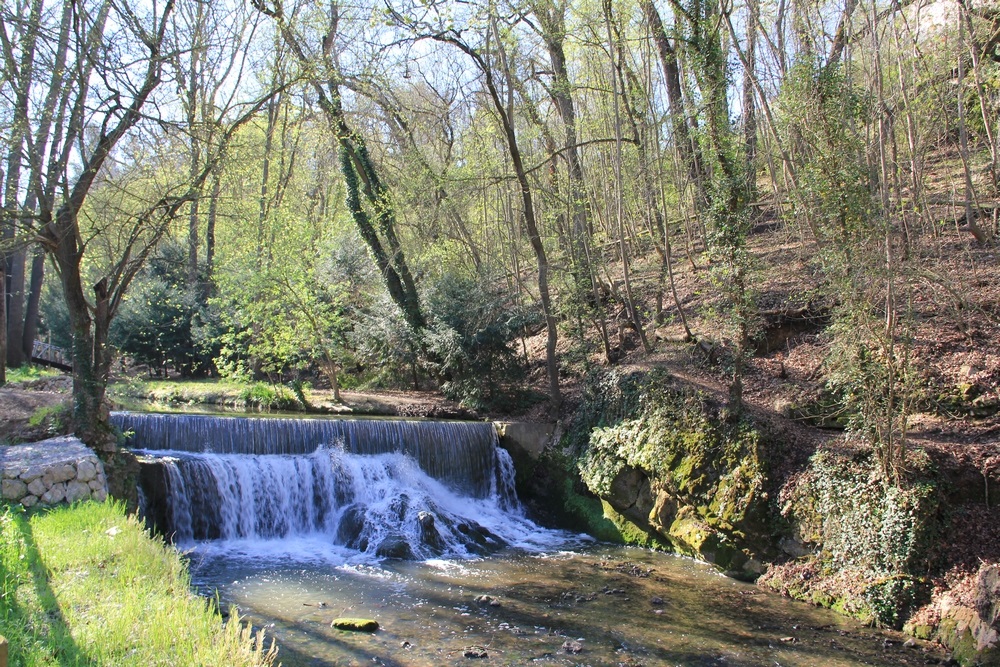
[193, 543, 944, 667]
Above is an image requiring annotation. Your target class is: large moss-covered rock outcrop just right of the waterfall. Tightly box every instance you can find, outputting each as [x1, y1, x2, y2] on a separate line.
[567, 370, 772, 576]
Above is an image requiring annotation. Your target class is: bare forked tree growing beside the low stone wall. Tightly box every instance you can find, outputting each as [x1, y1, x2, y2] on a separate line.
[2, 0, 272, 451]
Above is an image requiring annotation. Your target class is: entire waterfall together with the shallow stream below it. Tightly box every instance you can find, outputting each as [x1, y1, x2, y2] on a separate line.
[114, 413, 940, 667]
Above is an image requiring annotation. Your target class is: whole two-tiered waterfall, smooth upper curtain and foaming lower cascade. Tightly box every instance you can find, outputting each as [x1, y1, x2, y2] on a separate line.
[114, 413, 553, 560]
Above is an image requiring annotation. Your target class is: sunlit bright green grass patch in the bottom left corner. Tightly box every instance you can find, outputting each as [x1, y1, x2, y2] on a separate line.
[0, 502, 275, 667]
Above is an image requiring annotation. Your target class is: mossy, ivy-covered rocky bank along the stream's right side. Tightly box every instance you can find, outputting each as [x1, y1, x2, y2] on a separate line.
[559, 370, 1000, 665]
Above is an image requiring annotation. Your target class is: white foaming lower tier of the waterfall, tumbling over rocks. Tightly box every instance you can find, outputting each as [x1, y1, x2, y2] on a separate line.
[137, 447, 580, 565]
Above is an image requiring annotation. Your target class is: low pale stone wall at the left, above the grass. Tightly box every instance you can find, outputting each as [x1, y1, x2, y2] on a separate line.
[0, 436, 108, 507]
